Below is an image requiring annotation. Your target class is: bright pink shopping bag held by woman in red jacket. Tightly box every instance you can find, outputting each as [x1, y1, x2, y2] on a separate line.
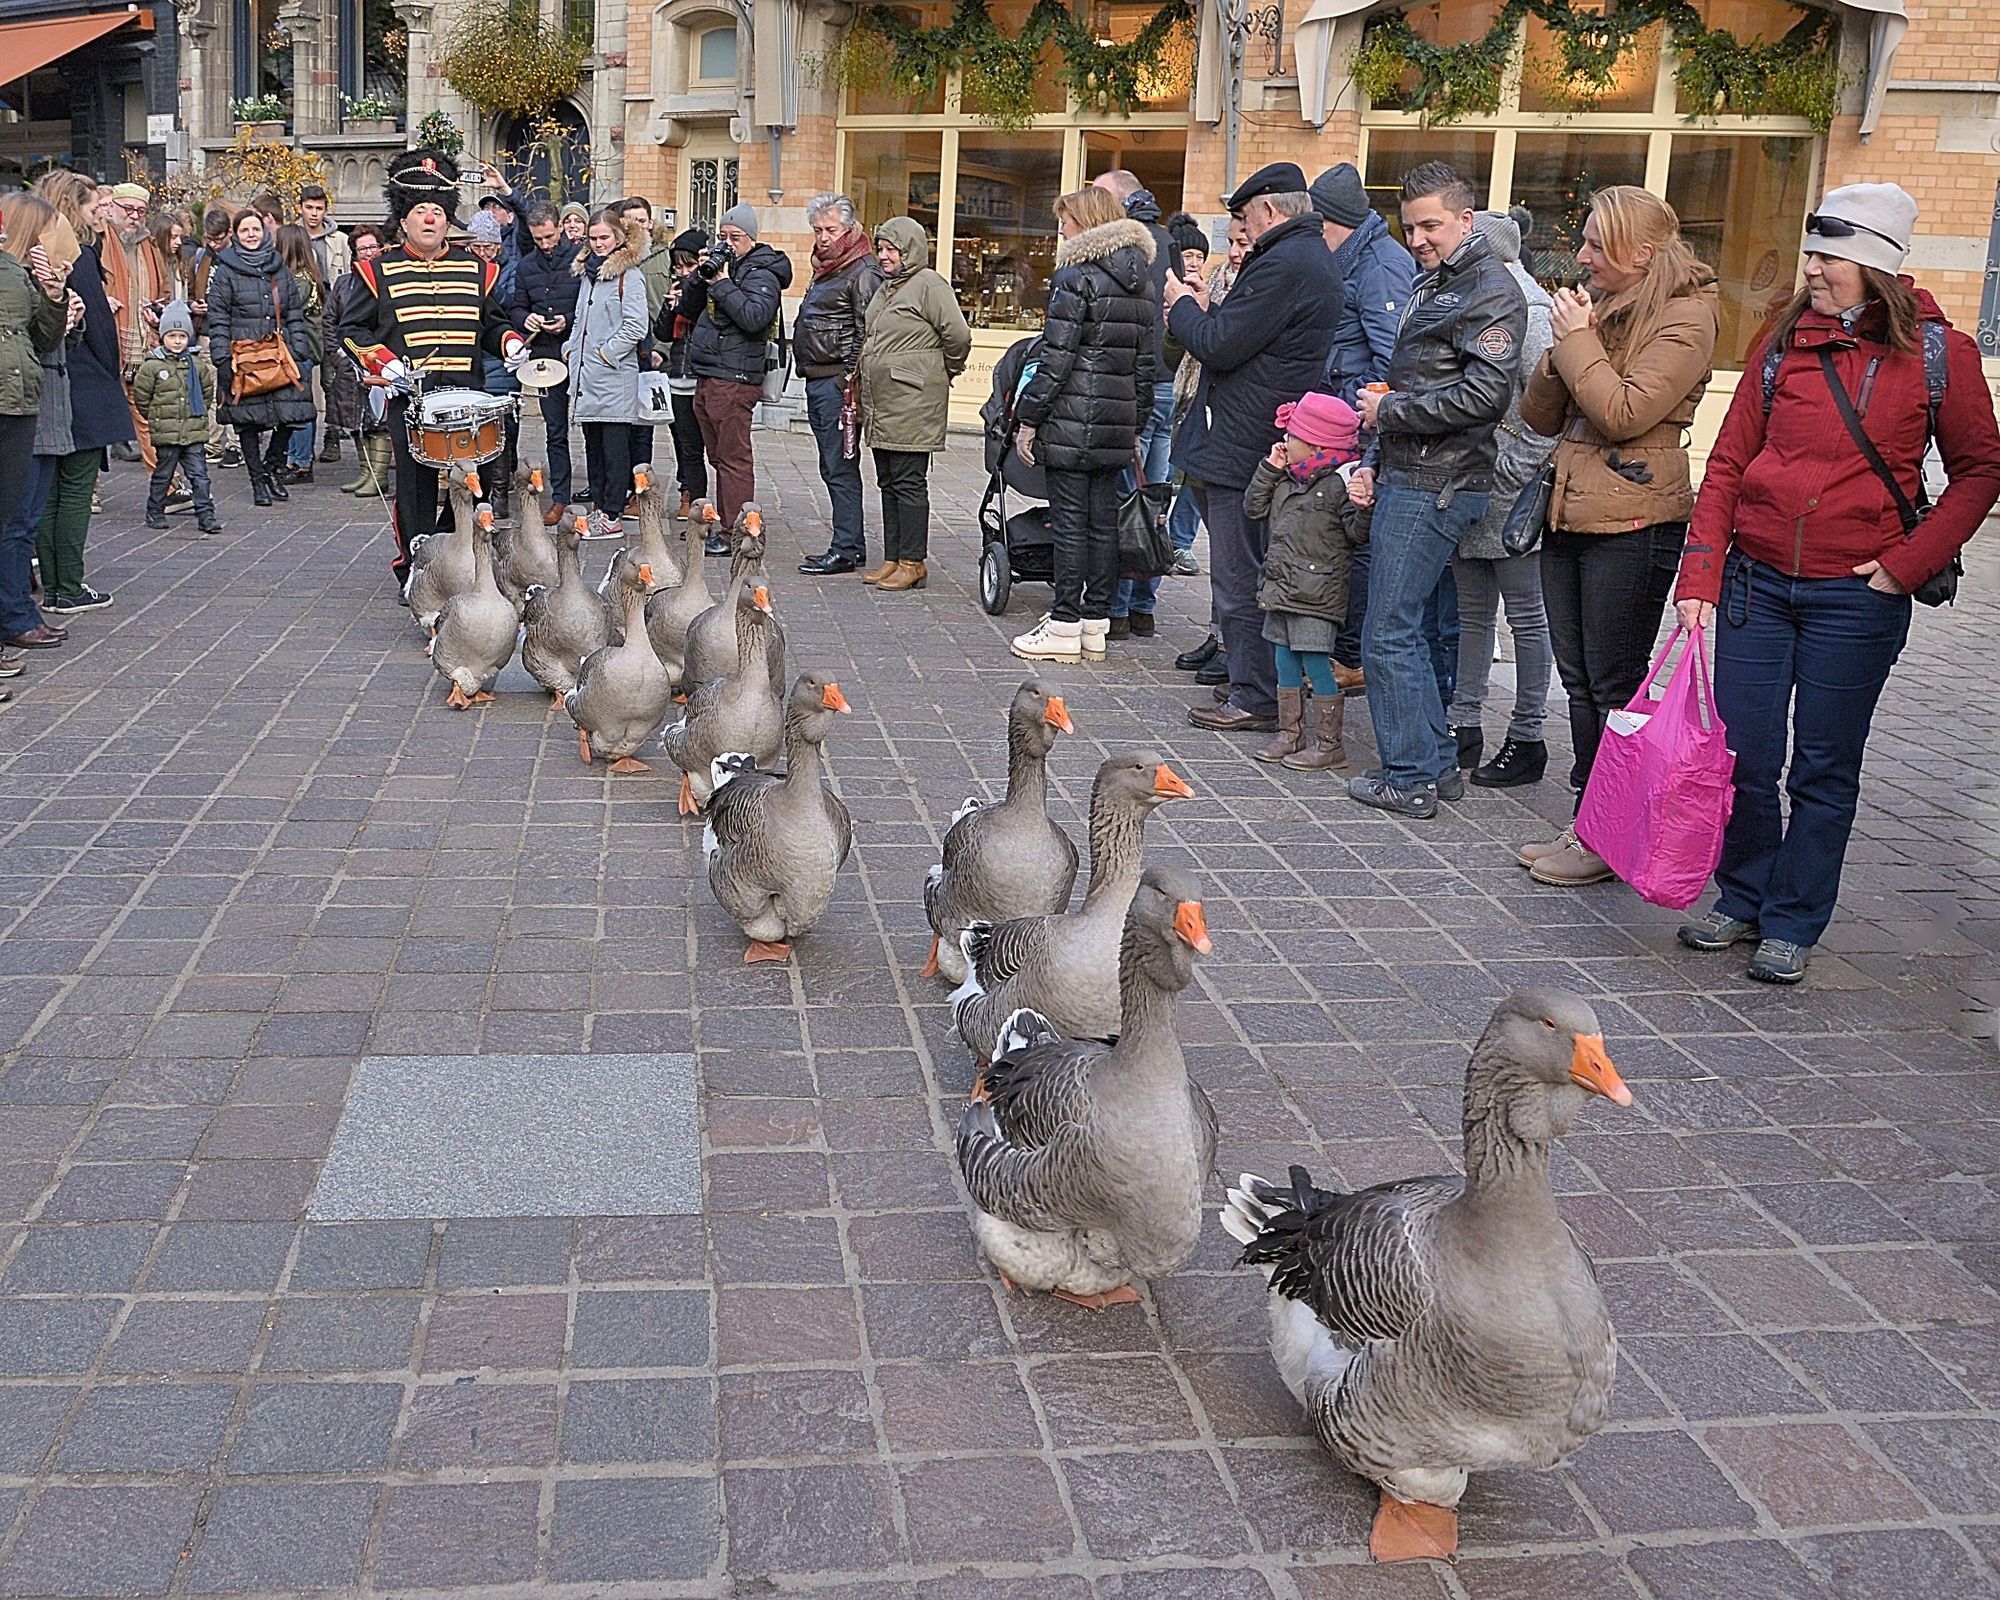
[1576, 628, 1736, 912]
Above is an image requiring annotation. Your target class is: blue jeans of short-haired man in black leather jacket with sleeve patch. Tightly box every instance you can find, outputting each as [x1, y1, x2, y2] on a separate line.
[1362, 478, 1488, 788]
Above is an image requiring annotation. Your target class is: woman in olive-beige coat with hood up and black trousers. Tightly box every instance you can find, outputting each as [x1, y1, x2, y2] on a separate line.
[856, 216, 972, 590]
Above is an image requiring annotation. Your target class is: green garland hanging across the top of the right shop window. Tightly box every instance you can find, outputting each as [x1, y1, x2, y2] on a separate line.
[1354, 0, 1842, 134]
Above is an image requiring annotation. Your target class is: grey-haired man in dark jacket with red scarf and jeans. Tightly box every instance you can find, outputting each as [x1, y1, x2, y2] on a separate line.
[792, 194, 882, 578]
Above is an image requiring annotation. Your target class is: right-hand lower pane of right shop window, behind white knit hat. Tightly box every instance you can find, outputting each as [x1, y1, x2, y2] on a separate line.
[1666, 134, 1812, 366]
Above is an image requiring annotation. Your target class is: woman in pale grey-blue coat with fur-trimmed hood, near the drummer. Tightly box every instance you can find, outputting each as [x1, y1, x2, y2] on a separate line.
[562, 206, 648, 538]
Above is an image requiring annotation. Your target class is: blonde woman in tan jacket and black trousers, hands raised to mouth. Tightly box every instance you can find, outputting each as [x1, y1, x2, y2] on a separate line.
[1520, 184, 1716, 886]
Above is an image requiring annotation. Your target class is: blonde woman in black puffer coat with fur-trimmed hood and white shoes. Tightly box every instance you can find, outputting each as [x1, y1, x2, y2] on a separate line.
[1014, 188, 1160, 662]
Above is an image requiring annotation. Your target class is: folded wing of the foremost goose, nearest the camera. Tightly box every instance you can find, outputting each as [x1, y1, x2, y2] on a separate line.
[1242, 1166, 1464, 1346]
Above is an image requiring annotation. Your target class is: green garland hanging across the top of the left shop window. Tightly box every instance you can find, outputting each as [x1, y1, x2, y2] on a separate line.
[814, 0, 1194, 130]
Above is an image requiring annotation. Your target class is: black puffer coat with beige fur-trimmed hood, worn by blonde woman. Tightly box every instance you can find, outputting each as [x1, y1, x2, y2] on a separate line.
[1014, 216, 1160, 472]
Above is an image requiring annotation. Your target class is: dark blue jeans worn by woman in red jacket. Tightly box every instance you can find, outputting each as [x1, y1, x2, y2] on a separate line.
[1716, 550, 1910, 944]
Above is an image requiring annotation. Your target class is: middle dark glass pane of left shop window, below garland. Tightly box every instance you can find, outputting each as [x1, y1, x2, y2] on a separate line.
[948, 132, 1064, 328]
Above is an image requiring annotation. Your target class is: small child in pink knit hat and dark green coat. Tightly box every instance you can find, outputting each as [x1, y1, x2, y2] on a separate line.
[1244, 394, 1362, 772]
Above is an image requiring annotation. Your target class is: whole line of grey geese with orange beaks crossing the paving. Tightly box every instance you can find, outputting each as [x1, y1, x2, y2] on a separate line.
[406, 468, 1632, 1562]
